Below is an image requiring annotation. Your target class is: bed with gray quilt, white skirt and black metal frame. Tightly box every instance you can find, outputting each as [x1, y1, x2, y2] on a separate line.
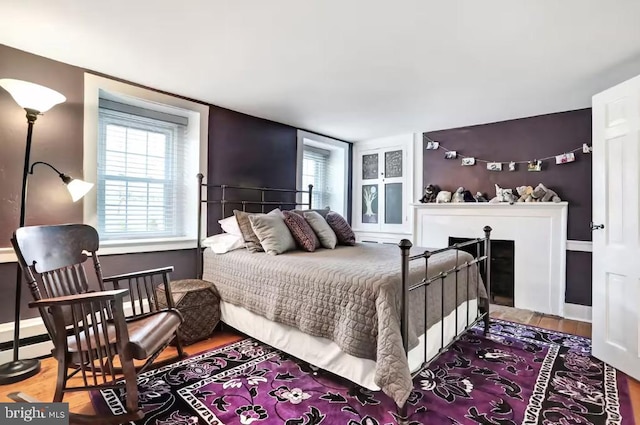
[195, 173, 491, 414]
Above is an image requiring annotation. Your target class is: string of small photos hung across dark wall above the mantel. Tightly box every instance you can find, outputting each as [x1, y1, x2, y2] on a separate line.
[423, 135, 593, 171]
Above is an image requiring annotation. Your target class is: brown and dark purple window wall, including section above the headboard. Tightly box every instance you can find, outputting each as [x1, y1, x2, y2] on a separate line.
[0, 44, 297, 326]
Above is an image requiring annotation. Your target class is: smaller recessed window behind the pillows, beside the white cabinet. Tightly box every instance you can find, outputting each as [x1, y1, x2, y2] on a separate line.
[298, 130, 350, 217]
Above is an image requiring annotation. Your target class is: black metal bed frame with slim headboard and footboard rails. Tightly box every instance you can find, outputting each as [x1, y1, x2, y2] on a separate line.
[197, 174, 492, 418]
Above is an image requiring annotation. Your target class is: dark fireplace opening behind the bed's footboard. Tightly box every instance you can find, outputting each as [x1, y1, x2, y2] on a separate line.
[449, 236, 515, 307]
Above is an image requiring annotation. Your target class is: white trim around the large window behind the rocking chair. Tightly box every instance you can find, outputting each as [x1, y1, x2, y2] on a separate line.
[83, 73, 209, 254]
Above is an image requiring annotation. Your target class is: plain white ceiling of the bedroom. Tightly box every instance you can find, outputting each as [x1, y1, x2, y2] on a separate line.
[0, 0, 640, 141]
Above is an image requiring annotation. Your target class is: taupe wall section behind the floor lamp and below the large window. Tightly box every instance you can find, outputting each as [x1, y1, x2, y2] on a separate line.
[0, 45, 202, 324]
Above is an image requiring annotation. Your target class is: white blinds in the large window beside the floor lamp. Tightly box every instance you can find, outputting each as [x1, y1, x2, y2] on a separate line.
[97, 99, 188, 240]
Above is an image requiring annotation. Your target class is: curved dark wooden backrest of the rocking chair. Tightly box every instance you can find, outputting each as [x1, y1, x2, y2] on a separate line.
[11, 224, 102, 341]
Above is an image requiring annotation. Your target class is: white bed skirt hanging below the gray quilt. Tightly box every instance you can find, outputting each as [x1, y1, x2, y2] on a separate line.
[220, 300, 478, 391]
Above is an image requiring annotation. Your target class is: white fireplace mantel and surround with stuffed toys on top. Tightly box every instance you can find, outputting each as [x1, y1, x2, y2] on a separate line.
[411, 202, 568, 316]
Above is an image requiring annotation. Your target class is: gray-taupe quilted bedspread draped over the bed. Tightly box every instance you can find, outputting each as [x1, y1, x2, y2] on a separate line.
[203, 243, 486, 405]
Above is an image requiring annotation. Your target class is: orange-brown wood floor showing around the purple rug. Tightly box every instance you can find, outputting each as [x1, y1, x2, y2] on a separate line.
[0, 306, 640, 425]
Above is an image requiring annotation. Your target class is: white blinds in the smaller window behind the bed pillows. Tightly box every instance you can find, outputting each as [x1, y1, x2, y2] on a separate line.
[302, 146, 331, 208]
